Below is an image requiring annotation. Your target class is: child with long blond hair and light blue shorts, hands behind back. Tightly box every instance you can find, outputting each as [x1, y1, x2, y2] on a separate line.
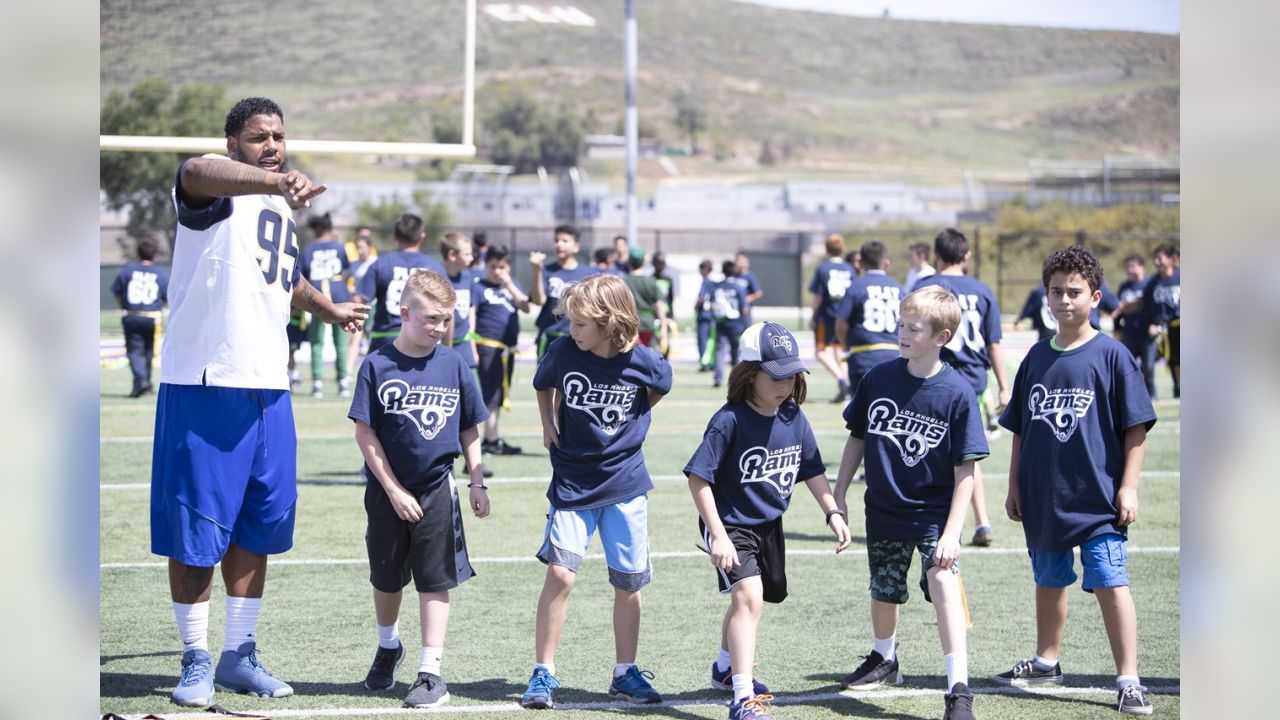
[521, 275, 671, 708]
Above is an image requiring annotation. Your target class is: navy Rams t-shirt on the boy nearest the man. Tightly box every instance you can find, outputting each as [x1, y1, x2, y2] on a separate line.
[347, 343, 489, 495]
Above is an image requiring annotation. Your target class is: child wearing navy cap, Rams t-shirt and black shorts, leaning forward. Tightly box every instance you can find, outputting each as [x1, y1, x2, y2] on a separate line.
[685, 323, 849, 720]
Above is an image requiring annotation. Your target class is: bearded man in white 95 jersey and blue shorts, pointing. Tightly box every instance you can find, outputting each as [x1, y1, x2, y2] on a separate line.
[151, 92, 369, 706]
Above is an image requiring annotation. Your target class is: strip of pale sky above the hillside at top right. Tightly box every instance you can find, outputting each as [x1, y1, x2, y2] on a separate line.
[739, 0, 1181, 35]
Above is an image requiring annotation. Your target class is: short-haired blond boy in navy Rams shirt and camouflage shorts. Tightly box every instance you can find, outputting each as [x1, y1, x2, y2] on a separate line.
[835, 287, 988, 720]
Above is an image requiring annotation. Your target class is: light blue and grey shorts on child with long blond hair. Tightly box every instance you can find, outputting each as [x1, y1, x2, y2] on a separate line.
[538, 495, 653, 591]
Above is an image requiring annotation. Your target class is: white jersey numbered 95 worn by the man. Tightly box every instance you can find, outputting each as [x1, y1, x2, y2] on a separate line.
[160, 179, 300, 389]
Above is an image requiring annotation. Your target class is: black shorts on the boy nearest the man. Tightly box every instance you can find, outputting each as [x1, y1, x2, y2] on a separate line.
[365, 477, 475, 593]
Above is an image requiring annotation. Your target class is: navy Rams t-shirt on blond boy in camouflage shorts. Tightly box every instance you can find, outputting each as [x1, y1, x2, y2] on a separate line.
[845, 359, 991, 541]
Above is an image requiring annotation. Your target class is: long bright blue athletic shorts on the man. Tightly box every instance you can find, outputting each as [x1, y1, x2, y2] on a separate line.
[151, 383, 298, 568]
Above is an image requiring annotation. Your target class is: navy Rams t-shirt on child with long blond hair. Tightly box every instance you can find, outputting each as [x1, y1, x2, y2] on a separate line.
[534, 337, 671, 510]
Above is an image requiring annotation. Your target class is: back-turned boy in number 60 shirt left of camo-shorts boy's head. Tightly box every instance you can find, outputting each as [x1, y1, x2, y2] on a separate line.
[836, 240, 902, 392]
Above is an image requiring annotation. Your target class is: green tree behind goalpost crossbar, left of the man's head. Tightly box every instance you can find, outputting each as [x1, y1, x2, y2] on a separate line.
[99, 78, 228, 247]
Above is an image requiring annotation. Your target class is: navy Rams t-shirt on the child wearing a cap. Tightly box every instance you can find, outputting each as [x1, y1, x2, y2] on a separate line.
[685, 400, 827, 525]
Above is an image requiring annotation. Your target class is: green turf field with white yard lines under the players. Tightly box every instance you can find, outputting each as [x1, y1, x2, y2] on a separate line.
[100, 340, 1180, 720]
